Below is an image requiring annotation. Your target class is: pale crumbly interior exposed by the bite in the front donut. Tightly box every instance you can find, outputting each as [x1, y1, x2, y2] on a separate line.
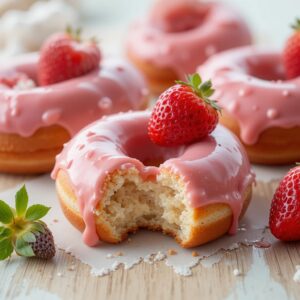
[97, 168, 192, 240]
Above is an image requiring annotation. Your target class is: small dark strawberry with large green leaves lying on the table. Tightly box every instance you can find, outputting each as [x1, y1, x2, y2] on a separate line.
[0, 186, 55, 260]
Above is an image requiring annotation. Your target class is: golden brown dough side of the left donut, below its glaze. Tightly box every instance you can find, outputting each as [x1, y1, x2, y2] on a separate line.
[0, 125, 70, 174]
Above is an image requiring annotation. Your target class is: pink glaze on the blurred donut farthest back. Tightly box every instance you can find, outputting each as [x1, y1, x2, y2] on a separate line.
[127, 0, 251, 79]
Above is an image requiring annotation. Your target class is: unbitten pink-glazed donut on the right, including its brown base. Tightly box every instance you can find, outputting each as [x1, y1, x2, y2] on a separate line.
[199, 47, 300, 164]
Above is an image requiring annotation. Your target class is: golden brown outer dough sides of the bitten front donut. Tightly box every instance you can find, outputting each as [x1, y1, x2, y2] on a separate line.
[56, 170, 252, 248]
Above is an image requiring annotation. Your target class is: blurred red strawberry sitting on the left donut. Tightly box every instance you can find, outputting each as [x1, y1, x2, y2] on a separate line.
[38, 29, 101, 85]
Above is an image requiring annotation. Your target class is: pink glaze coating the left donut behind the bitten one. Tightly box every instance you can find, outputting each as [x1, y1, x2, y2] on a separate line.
[0, 55, 146, 137]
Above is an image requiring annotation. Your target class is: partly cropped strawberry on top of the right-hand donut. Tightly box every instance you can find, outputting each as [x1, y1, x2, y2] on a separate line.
[283, 19, 300, 79]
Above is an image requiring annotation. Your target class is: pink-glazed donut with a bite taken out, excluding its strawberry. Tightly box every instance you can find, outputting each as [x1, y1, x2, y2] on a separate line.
[52, 111, 254, 248]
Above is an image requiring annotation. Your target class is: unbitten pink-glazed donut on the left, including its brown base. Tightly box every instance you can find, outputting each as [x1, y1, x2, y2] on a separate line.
[0, 55, 146, 173]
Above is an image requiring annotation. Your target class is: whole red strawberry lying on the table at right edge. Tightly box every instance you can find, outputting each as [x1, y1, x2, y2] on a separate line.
[269, 166, 300, 241]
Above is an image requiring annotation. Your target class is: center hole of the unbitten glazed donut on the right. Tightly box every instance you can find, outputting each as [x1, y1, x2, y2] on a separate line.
[247, 56, 286, 81]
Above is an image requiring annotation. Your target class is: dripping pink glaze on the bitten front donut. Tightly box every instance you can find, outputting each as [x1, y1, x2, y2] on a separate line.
[52, 111, 254, 246]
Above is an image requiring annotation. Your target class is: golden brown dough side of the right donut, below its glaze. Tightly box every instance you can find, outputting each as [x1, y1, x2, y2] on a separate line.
[220, 110, 300, 165]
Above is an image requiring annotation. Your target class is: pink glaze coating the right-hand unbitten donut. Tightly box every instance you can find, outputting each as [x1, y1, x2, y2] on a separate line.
[198, 47, 300, 145]
